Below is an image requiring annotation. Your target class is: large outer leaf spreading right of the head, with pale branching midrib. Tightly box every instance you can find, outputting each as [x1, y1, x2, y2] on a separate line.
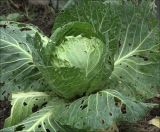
[110, 1, 160, 99]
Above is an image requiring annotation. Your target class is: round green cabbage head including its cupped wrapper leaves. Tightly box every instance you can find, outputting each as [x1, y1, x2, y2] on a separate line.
[34, 22, 113, 99]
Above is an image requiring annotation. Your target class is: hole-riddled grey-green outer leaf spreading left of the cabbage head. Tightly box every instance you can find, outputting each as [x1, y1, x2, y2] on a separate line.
[0, 21, 48, 100]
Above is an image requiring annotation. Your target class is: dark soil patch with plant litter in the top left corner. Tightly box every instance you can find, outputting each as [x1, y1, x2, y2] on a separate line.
[0, 0, 56, 36]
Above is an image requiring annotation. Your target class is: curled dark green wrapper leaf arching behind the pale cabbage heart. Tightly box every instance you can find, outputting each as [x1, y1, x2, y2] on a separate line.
[50, 21, 104, 45]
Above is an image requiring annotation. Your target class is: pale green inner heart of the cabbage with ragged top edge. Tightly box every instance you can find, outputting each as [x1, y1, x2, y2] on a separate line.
[52, 35, 104, 71]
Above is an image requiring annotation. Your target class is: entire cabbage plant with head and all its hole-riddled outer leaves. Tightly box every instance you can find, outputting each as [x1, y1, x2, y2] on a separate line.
[0, 0, 160, 132]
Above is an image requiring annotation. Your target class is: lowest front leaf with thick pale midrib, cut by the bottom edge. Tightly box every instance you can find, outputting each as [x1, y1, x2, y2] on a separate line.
[0, 106, 80, 132]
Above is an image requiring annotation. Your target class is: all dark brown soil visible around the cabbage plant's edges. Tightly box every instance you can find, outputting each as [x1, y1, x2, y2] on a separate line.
[0, 0, 160, 132]
